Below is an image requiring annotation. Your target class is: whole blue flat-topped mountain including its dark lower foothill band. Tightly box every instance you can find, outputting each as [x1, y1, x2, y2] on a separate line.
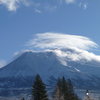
[0, 50, 100, 92]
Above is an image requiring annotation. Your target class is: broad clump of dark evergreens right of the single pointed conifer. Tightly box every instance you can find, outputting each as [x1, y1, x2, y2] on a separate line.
[54, 77, 79, 100]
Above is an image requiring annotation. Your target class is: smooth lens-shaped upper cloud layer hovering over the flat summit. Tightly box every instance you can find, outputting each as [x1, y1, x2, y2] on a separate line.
[28, 33, 97, 50]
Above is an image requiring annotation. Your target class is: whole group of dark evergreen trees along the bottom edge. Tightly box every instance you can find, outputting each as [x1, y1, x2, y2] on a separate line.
[22, 75, 80, 100]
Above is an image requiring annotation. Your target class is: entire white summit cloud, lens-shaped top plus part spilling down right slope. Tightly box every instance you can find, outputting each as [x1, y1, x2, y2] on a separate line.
[27, 33, 100, 65]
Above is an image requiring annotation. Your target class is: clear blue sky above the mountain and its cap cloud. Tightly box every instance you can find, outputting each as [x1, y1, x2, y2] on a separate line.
[0, 0, 100, 67]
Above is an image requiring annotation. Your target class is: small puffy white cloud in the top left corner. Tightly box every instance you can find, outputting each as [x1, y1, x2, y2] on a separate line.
[0, 0, 29, 11]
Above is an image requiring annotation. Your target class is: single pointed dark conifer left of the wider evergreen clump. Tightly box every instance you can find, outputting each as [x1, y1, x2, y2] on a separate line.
[32, 75, 48, 100]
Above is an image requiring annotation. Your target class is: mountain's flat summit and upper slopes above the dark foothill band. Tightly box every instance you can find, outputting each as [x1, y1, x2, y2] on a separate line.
[0, 49, 100, 89]
